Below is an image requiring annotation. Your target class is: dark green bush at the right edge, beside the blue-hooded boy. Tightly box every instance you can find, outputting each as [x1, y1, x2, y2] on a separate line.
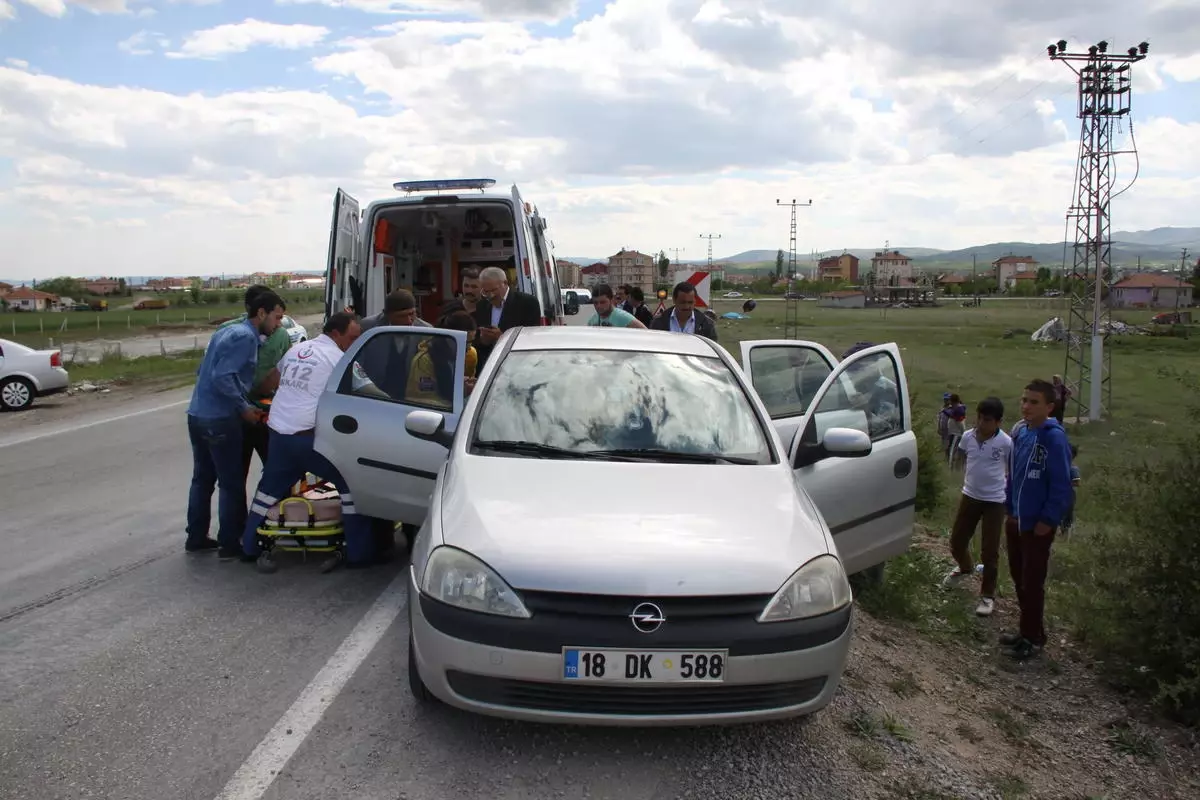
[1050, 378, 1200, 724]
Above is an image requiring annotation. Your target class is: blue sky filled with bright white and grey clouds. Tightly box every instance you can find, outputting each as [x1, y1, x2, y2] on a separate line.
[0, 0, 1200, 279]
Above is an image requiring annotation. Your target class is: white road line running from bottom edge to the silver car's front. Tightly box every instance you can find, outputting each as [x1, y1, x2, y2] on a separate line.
[216, 570, 408, 800]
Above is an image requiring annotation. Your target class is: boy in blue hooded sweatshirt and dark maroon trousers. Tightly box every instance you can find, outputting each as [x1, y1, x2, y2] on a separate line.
[1000, 380, 1073, 661]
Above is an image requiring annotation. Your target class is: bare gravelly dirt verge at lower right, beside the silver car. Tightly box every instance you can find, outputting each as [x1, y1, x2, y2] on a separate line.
[822, 585, 1200, 800]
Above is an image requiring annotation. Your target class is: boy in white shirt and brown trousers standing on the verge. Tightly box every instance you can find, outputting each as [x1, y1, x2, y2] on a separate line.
[947, 397, 1013, 616]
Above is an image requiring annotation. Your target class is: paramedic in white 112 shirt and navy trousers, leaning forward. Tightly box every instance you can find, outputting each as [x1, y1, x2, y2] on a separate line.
[241, 312, 374, 571]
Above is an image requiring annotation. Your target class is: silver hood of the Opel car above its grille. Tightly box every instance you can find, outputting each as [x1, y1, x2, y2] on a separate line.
[440, 455, 832, 596]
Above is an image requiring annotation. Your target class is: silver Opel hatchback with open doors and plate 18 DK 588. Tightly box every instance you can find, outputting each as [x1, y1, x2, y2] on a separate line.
[316, 326, 917, 726]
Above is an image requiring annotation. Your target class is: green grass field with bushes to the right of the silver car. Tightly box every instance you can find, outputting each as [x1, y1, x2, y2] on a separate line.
[718, 301, 1200, 723]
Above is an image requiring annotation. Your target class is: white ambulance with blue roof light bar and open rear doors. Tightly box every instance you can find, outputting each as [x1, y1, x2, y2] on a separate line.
[325, 179, 565, 325]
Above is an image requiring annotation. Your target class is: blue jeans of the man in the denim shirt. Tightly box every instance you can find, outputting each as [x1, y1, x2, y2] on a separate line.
[187, 415, 246, 548]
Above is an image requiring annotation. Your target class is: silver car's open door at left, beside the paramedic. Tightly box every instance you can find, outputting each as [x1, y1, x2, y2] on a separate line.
[314, 326, 467, 525]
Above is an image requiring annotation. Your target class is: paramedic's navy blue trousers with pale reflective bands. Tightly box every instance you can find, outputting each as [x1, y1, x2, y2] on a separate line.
[241, 431, 374, 564]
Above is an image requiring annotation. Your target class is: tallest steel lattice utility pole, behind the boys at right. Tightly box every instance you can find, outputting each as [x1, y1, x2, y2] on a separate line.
[1046, 40, 1150, 422]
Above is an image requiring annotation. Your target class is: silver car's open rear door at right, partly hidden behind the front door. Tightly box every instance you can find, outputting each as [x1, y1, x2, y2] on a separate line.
[742, 339, 838, 447]
